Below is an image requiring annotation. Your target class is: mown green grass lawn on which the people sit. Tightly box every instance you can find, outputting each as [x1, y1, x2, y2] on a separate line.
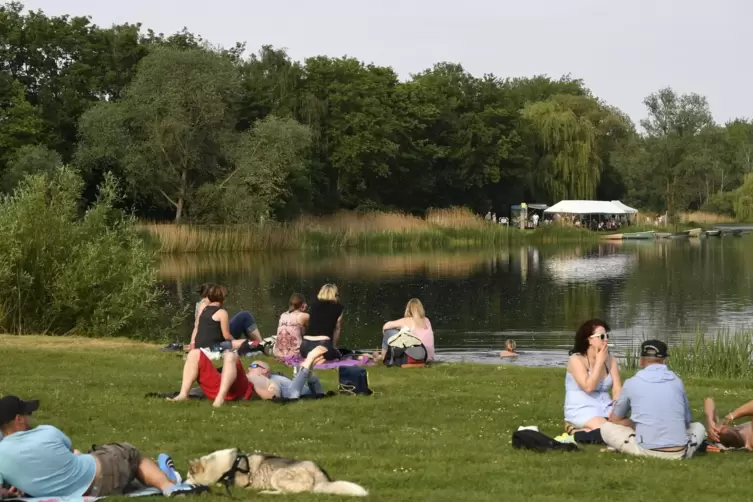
[0, 336, 753, 501]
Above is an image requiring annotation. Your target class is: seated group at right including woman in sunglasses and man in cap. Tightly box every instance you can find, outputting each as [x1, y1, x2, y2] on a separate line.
[555, 319, 753, 459]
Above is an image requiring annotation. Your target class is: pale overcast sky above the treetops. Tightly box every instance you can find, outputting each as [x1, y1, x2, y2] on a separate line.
[22, 0, 753, 123]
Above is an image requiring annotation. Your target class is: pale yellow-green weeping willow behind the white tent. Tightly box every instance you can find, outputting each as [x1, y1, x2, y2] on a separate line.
[522, 95, 611, 200]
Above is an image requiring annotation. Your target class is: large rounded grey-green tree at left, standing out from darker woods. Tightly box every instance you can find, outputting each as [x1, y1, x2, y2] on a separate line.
[78, 47, 240, 222]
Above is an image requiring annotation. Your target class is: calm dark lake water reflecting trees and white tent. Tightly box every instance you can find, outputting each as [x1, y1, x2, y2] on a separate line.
[160, 235, 753, 365]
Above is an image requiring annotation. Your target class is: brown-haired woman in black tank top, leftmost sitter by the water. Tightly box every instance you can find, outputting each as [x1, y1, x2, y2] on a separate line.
[188, 284, 258, 352]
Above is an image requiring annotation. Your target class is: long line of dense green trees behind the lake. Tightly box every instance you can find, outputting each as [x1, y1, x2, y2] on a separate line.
[0, 2, 753, 223]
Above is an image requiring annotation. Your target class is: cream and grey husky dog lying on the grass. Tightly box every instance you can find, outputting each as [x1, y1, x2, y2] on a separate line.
[186, 448, 368, 497]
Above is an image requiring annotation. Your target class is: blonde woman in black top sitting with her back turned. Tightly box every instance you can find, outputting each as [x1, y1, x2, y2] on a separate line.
[301, 284, 345, 361]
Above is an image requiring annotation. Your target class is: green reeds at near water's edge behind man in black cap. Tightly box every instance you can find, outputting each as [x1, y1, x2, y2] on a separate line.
[625, 330, 753, 380]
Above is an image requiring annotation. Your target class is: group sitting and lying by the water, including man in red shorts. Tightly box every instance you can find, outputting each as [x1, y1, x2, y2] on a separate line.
[171, 284, 434, 407]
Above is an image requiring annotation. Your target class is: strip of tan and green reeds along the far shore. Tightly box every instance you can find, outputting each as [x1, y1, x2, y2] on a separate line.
[141, 209, 598, 253]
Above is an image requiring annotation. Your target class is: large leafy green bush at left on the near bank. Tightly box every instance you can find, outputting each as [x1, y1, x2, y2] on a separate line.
[0, 167, 179, 338]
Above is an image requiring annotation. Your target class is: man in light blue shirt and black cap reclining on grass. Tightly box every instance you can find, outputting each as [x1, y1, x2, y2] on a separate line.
[0, 396, 197, 497]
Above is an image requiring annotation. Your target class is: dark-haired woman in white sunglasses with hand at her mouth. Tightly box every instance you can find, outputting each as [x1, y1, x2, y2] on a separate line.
[565, 319, 622, 431]
